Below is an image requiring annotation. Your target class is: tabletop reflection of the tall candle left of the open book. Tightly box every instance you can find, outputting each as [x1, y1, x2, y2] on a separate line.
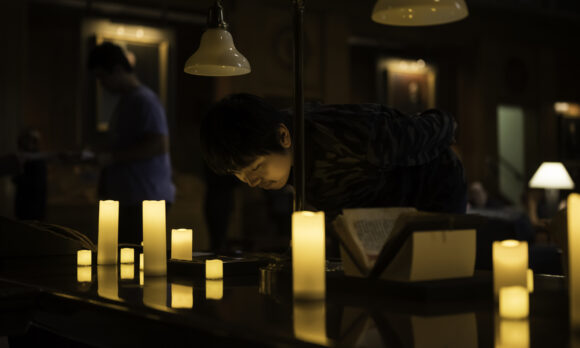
[294, 300, 328, 345]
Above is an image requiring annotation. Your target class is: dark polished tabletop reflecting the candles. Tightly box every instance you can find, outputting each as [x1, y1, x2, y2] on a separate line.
[0, 255, 570, 347]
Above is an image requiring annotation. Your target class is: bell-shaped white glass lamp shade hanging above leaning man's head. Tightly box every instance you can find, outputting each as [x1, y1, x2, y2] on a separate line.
[183, 28, 252, 76]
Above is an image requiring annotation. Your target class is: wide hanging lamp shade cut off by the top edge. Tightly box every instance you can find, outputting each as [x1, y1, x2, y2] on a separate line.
[371, 0, 468, 26]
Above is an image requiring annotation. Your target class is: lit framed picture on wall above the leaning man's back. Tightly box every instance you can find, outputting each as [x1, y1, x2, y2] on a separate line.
[379, 58, 436, 113]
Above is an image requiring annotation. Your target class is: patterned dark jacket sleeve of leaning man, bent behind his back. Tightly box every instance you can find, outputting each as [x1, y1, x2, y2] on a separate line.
[367, 107, 457, 169]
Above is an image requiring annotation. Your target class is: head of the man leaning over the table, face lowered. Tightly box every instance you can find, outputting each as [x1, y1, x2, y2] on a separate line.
[200, 94, 292, 189]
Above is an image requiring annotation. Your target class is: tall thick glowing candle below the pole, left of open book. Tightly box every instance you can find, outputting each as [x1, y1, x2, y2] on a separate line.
[292, 211, 326, 299]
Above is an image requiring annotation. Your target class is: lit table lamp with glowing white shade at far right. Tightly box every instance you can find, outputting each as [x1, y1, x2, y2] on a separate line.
[528, 162, 574, 216]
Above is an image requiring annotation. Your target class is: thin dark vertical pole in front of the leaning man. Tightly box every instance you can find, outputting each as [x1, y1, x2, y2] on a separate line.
[292, 0, 306, 211]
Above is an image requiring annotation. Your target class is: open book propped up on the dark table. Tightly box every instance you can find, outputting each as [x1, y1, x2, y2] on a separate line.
[333, 208, 481, 281]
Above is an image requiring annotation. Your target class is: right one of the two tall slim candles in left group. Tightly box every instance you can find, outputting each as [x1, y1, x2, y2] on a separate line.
[143, 201, 167, 277]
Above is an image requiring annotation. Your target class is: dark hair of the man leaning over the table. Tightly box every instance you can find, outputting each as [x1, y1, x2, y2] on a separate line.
[200, 93, 287, 174]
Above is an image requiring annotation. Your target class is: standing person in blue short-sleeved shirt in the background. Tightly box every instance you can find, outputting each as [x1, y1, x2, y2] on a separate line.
[88, 42, 175, 244]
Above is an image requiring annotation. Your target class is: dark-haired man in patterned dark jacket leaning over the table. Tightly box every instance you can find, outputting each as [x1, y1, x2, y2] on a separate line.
[201, 94, 466, 219]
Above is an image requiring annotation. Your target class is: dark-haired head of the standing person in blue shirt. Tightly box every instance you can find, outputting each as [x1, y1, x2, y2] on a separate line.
[88, 42, 135, 93]
